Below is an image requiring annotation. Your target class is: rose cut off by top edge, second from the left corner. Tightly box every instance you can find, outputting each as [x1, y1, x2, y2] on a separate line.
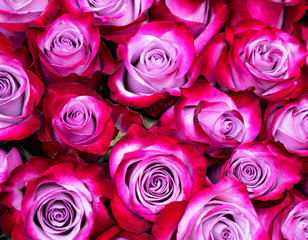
[63, 0, 154, 44]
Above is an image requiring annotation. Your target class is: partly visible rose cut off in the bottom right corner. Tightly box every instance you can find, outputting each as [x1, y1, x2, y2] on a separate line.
[256, 191, 308, 240]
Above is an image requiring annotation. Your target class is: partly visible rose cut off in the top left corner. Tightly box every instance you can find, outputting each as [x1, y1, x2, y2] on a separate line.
[0, 0, 61, 32]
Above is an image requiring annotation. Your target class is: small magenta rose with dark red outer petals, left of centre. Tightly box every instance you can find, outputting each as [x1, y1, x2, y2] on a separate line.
[39, 83, 114, 158]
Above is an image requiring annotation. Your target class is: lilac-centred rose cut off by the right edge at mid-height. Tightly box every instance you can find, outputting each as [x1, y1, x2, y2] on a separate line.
[260, 94, 308, 157]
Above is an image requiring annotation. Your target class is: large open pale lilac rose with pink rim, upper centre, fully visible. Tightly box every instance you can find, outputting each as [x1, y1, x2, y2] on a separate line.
[108, 22, 200, 116]
